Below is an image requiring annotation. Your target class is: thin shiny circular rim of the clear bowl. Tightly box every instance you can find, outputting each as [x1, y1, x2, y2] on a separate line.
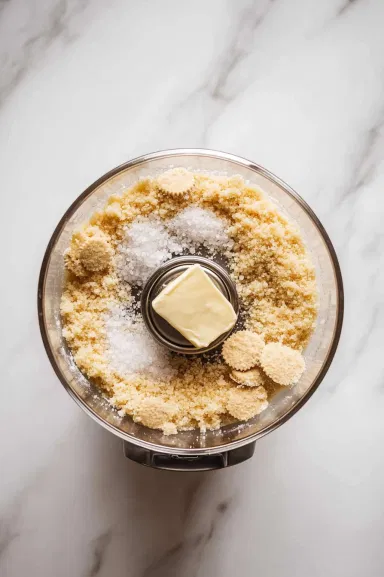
[37, 148, 344, 456]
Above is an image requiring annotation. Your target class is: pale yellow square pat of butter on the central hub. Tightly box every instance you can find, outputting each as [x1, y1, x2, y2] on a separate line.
[152, 264, 237, 348]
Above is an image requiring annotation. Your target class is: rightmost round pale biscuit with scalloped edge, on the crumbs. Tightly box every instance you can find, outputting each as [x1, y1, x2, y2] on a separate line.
[260, 343, 305, 387]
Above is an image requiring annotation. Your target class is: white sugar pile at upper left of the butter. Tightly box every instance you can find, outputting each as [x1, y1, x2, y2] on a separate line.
[116, 217, 182, 286]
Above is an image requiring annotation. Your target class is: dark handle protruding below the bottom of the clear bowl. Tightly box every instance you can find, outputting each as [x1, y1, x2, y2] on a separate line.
[124, 441, 255, 471]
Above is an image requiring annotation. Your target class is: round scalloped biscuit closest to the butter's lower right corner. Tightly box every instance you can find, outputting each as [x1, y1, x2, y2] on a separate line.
[223, 331, 265, 371]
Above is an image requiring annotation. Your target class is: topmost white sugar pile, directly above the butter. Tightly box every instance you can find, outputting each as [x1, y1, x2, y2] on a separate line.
[167, 206, 233, 252]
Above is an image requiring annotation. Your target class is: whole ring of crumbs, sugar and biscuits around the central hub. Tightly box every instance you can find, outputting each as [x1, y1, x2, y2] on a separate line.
[61, 168, 317, 434]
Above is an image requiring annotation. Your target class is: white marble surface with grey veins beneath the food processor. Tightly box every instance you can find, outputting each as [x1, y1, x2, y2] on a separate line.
[0, 0, 384, 577]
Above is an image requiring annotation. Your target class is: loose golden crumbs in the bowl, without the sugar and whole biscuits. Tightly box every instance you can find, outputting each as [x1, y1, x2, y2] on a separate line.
[61, 169, 317, 434]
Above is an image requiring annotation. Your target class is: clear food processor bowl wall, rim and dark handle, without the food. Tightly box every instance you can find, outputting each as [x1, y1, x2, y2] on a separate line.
[38, 149, 343, 471]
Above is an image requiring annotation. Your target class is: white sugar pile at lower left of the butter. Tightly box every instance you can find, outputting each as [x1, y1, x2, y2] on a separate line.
[105, 306, 174, 380]
